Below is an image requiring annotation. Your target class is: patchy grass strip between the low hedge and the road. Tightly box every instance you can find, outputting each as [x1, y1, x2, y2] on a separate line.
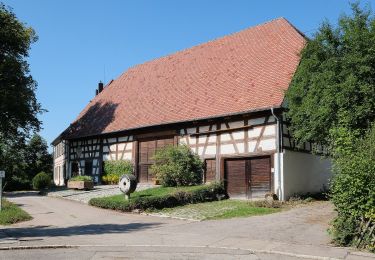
[148, 200, 281, 220]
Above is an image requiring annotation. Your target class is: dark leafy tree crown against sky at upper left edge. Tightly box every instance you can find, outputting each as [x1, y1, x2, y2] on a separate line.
[0, 3, 43, 142]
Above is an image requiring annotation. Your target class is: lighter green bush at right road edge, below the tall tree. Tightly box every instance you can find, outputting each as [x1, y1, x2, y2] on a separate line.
[331, 125, 375, 250]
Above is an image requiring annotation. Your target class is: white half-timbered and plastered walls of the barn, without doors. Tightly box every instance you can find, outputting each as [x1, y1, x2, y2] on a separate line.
[54, 112, 331, 200]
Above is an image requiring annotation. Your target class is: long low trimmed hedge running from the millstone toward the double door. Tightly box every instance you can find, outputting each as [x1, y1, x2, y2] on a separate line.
[89, 183, 227, 212]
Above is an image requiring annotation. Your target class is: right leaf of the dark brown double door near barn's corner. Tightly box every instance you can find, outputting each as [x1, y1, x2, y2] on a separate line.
[249, 157, 271, 198]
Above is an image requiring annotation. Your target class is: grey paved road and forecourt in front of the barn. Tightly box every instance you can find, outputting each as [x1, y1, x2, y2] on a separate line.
[0, 194, 370, 259]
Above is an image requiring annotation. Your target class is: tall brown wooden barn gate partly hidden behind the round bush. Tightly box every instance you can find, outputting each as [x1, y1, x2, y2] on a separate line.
[138, 137, 174, 182]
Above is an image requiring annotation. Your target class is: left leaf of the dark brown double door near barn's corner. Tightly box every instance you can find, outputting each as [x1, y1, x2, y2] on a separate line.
[225, 159, 249, 198]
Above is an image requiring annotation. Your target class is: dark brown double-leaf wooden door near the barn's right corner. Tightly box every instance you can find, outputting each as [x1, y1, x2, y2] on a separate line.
[225, 157, 271, 198]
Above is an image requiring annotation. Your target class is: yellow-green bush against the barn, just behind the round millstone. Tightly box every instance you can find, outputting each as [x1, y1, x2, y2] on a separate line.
[102, 160, 134, 184]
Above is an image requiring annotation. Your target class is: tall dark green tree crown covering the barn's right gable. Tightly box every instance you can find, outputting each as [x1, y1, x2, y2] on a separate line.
[286, 3, 375, 149]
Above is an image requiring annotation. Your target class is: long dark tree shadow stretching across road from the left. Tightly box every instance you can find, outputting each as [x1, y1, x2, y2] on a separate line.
[4, 223, 161, 239]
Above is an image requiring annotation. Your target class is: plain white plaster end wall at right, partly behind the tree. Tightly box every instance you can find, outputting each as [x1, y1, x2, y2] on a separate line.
[282, 150, 332, 200]
